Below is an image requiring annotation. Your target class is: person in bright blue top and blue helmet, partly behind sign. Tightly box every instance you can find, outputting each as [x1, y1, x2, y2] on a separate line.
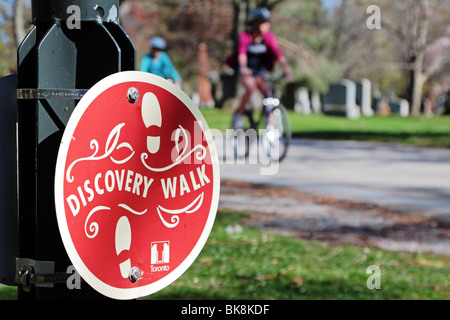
[139, 37, 182, 87]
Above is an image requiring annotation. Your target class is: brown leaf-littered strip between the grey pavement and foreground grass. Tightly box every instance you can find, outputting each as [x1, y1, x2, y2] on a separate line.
[219, 179, 450, 256]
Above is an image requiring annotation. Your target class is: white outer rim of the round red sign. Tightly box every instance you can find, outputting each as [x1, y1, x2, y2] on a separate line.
[55, 71, 220, 300]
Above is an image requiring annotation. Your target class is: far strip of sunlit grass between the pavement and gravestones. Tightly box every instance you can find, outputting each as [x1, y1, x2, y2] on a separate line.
[202, 109, 450, 148]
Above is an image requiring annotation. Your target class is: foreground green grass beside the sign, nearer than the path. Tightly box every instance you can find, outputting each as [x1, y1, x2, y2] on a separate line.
[0, 212, 450, 300]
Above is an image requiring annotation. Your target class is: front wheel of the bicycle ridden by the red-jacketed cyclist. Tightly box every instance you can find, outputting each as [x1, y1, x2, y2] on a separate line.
[262, 105, 292, 162]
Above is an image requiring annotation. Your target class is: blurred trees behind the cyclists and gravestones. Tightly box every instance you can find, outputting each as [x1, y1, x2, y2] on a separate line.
[0, 0, 450, 114]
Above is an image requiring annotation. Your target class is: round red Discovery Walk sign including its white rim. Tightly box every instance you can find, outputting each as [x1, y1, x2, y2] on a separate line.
[55, 71, 220, 299]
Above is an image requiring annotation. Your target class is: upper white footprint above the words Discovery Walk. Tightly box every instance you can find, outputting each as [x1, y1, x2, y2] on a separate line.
[141, 92, 162, 154]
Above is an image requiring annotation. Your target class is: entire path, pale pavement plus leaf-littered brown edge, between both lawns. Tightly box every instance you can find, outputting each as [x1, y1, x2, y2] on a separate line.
[216, 138, 450, 256]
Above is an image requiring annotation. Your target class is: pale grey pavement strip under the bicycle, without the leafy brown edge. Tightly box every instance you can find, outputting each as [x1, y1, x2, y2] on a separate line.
[216, 138, 450, 217]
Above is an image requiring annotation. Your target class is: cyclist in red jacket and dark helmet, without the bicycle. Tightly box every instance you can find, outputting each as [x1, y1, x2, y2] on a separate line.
[233, 8, 292, 128]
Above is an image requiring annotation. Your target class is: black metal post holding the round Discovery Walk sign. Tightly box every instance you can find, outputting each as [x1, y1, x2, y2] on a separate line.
[17, 0, 136, 299]
